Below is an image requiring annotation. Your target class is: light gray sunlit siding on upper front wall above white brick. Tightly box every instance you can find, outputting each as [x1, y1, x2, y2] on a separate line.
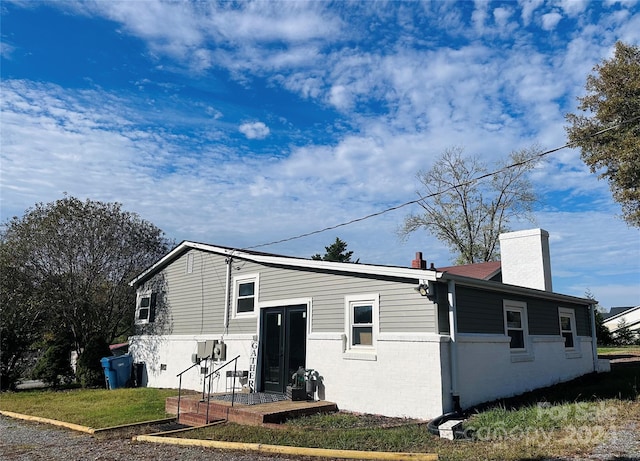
[139, 249, 438, 335]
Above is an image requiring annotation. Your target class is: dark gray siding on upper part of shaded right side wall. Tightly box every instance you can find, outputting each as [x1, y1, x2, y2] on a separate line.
[456, 286, 591, 336]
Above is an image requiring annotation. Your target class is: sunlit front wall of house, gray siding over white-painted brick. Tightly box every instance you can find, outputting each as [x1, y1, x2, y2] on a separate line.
[130, 249, 450, 419]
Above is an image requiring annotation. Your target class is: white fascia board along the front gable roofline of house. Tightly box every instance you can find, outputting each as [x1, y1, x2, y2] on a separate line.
[129, 241, 442, 286]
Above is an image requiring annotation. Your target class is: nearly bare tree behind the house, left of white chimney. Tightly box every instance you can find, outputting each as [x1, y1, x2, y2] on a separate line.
[399, 148, 539, 264]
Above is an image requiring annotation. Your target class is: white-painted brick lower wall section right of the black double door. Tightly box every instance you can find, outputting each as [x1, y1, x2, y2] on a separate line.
[307, 333, 450, 419]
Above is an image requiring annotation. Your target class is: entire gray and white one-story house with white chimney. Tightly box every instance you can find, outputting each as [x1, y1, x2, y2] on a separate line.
[129, 229, 597, 419]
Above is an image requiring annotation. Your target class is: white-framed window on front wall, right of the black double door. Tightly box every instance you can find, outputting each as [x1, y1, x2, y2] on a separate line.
[345, 294, 379, 351]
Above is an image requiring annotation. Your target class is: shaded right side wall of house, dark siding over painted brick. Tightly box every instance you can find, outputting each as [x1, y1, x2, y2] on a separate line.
[456, 286, 594, 408]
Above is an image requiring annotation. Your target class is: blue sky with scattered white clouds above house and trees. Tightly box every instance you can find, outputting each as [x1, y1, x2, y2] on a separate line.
[0, 0, 640, 308]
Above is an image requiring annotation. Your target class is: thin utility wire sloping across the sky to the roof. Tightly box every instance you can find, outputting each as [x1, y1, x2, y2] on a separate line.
[244, 115, 640, 250]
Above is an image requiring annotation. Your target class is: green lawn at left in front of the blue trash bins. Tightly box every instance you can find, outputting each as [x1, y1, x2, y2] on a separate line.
[0, 388, 177, 428]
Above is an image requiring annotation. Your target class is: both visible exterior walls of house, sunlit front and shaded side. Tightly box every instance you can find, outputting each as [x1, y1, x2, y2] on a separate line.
[130, 244, 593, 419]
